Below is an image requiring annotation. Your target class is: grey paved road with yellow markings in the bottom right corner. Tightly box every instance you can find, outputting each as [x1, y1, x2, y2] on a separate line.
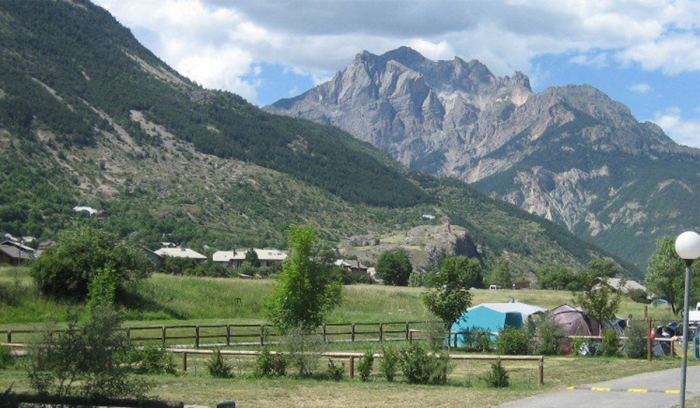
[498, 367, 700, 408]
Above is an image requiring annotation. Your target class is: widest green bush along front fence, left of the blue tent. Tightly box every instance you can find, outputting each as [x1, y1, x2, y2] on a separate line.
[400, 343, 450, 384]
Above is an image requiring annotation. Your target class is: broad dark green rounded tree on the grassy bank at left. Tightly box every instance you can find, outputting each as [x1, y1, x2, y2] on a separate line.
[32, 227, 153, 300]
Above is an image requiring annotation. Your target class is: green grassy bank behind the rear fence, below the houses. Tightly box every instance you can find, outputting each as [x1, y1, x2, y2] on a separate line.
[0, 268, 670, 328]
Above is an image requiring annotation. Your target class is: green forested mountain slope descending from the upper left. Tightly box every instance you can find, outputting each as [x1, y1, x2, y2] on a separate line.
[0, 0, 638, 274]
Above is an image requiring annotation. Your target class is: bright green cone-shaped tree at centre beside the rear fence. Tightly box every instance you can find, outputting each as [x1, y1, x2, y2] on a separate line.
[265, 226, 342, 332]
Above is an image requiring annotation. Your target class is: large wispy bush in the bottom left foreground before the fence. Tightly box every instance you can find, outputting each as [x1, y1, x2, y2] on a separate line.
[26, 306, 150, 398]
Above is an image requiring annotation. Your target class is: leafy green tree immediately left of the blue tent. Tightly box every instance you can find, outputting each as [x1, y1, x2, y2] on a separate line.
[423, 256, 476, 328]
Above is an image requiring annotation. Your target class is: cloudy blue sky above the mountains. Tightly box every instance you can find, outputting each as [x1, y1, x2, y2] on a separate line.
[93, 0, 700, 147]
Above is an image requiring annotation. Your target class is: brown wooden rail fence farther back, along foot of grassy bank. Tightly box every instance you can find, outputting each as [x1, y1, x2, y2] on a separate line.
[0, 321, 436, 348]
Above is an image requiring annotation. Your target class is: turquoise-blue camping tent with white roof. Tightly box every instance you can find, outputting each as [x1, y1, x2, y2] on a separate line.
[450, 302, 546, 346]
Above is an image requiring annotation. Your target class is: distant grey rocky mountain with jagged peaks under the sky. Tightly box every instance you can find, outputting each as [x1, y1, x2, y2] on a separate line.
[266, 47, 700, 266]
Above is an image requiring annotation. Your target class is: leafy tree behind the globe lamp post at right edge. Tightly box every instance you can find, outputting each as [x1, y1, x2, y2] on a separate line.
[645, 237, 700, 314]
